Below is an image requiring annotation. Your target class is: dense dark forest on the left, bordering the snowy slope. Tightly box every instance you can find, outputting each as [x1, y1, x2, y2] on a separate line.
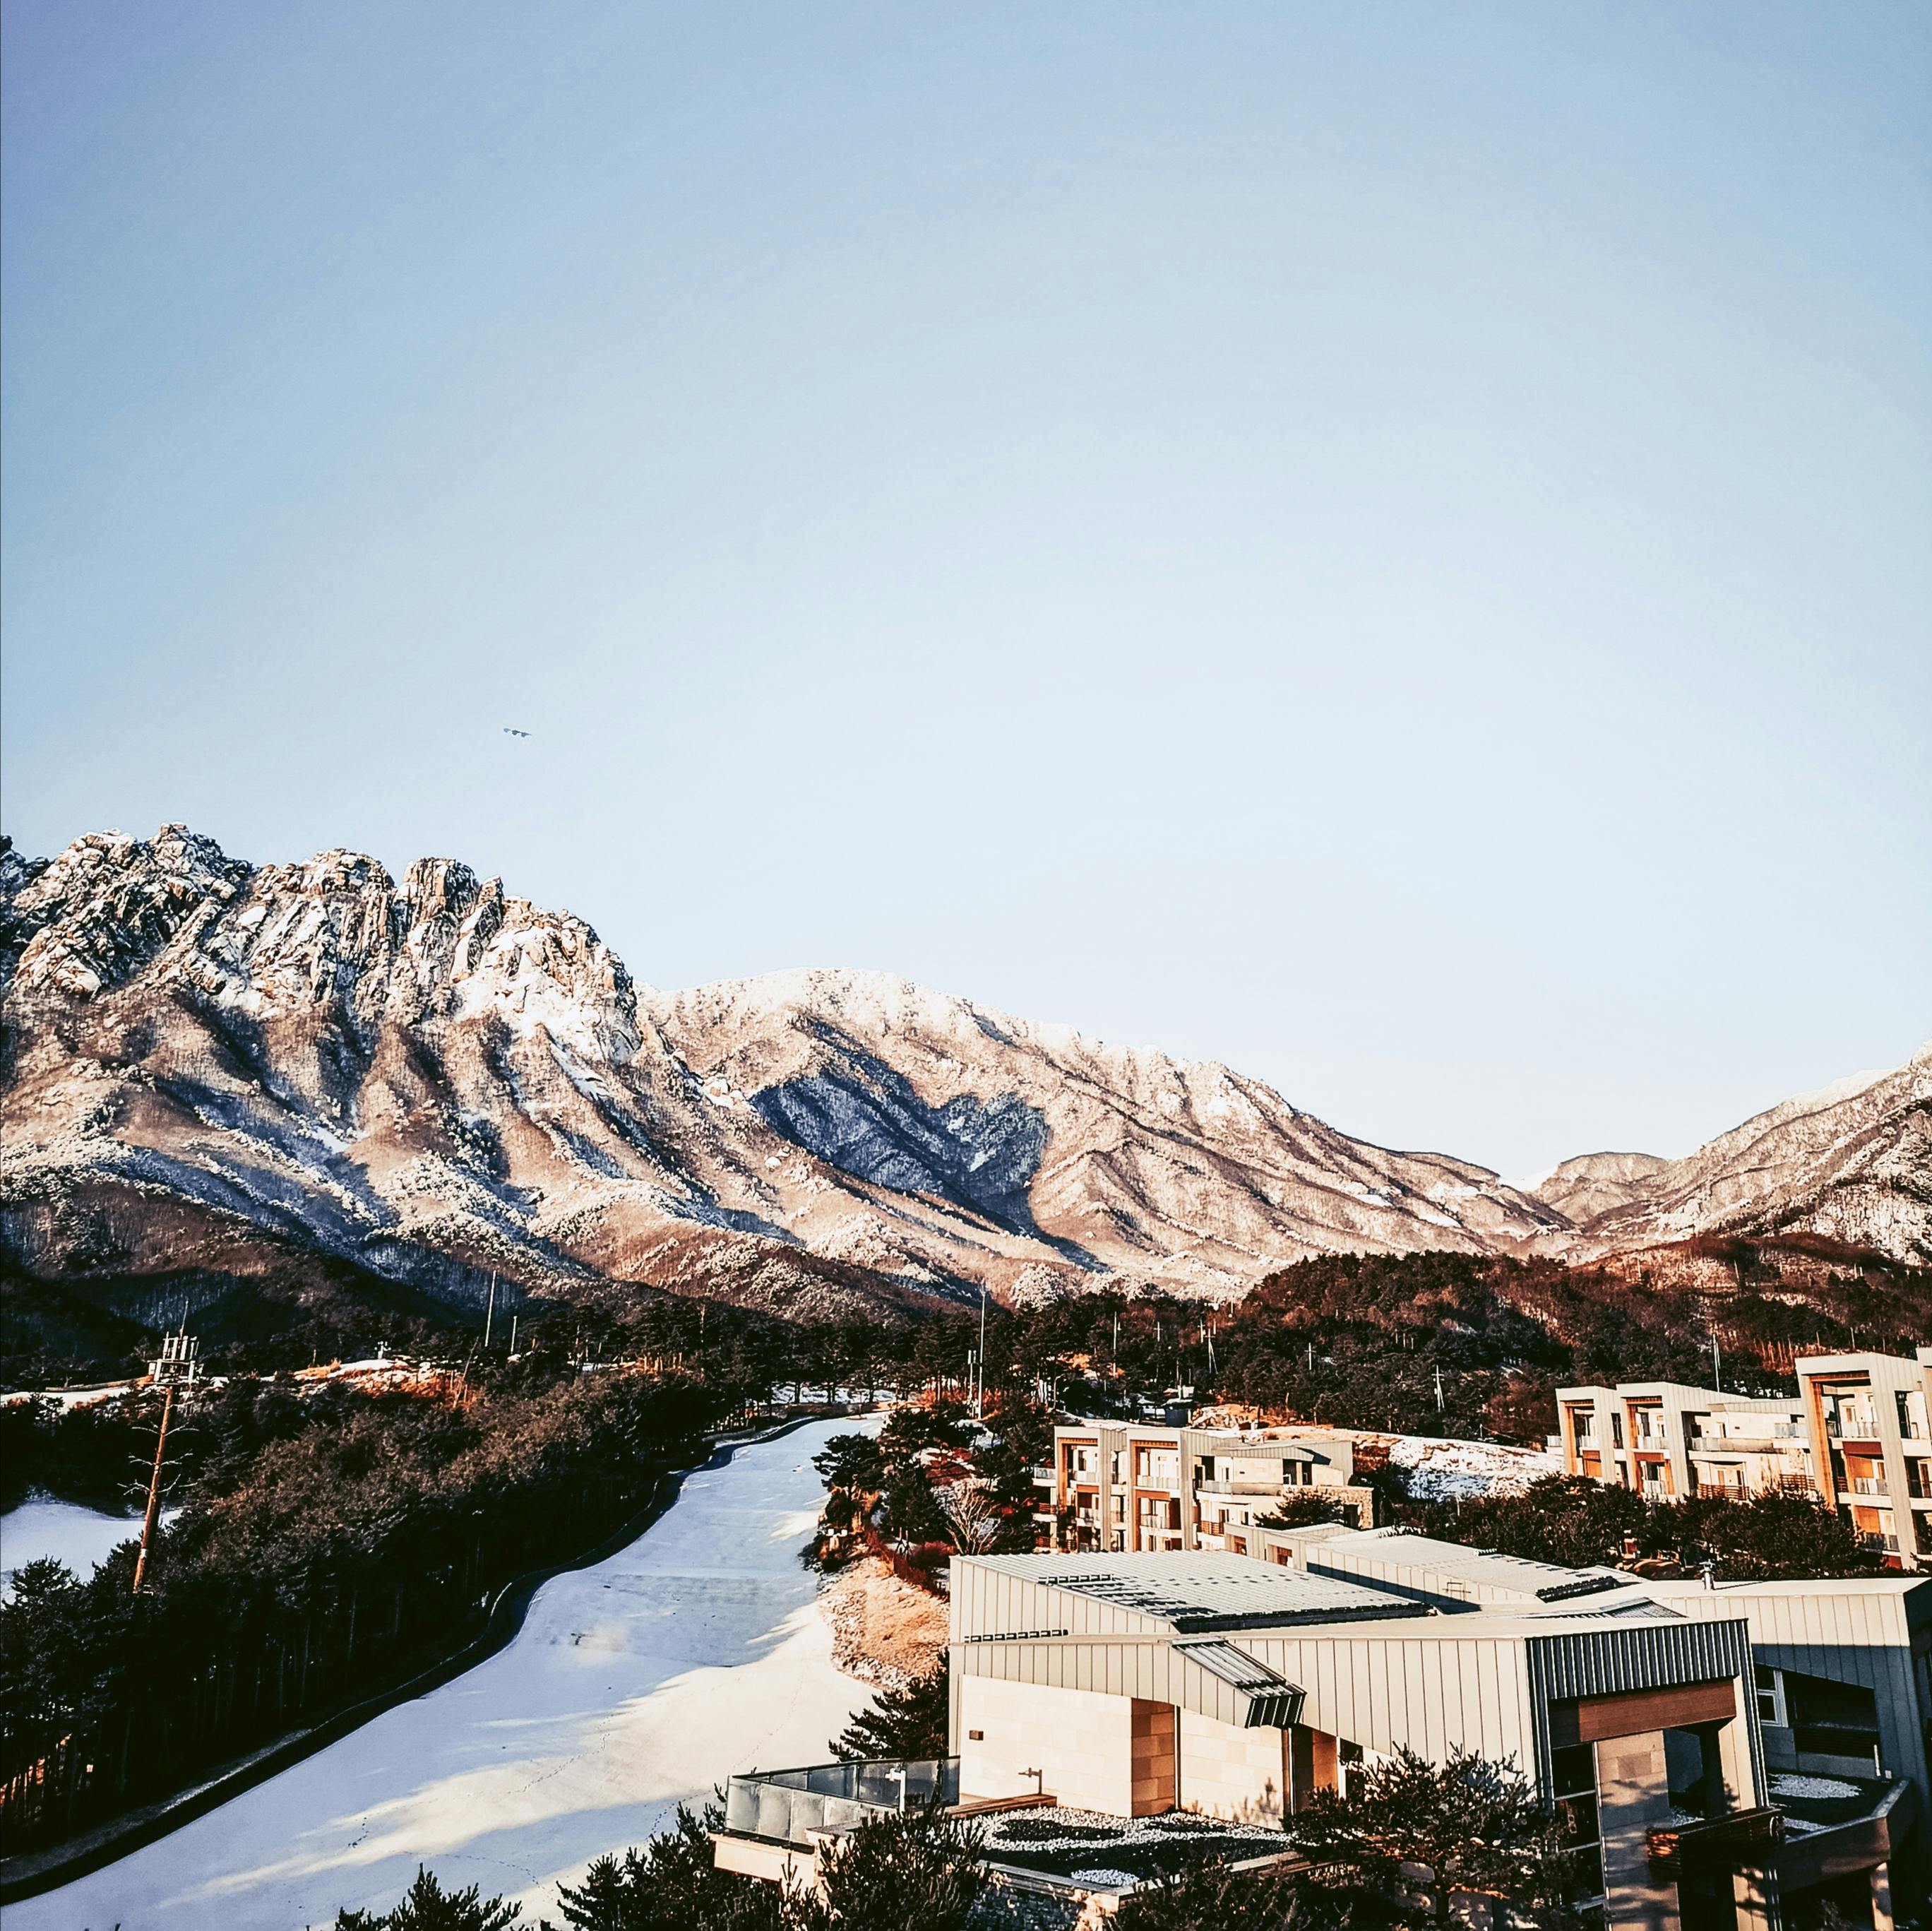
[0, 1362, 738, 1850]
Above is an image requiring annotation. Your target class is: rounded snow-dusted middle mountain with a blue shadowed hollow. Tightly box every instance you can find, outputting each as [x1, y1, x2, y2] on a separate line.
[641, 973, 1561, 1293]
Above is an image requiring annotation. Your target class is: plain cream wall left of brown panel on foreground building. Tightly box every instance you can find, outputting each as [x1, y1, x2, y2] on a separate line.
[958, 1676, 1134, 1817]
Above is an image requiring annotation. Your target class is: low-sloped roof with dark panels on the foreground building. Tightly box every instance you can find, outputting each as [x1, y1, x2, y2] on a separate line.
[972, 1550, 1426, 1634]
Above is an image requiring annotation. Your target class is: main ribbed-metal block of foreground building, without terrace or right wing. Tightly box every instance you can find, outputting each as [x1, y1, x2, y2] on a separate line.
[950, 1554, 1775, 1931]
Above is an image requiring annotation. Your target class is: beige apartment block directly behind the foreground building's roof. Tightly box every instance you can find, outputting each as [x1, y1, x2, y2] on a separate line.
[1053, 1421, 1376, 1556]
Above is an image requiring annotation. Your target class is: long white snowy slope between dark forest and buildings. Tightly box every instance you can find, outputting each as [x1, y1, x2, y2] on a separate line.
[6, 1419, 875, 1931]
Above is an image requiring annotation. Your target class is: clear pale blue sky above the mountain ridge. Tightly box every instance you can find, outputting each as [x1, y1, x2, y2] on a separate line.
[4, 0, 1932, 1173]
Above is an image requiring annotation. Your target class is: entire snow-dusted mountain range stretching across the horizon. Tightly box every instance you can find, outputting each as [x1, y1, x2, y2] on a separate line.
[0, 826, 1928, 1312]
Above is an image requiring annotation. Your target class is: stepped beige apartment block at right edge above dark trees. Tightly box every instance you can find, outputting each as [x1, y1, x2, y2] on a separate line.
[1557, 1348, 1932, 1569]
